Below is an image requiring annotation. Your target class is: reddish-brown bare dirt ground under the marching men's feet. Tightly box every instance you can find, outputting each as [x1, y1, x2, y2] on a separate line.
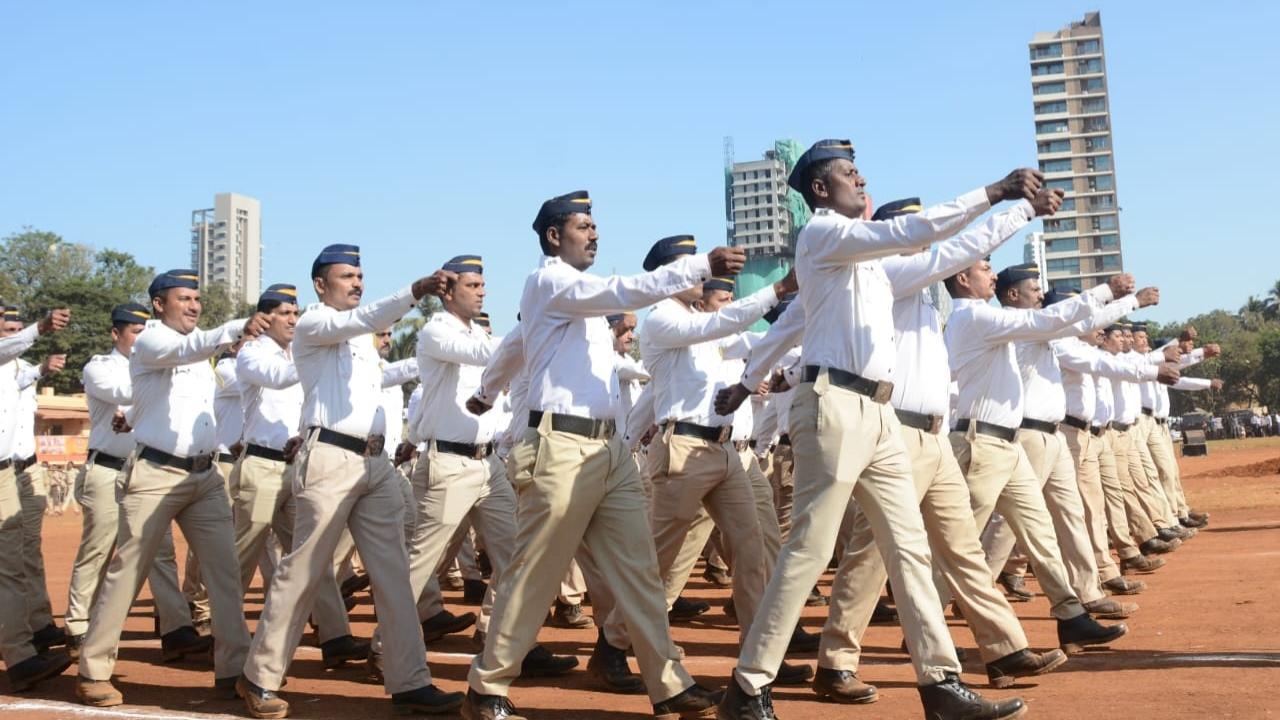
[0, 439, 1280, 720]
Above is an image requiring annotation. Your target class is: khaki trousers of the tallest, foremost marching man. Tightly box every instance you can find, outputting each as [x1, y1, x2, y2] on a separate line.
[735, 370, 972, 694]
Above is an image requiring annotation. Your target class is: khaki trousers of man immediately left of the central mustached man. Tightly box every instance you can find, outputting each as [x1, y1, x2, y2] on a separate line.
[374, 441, 516, 652]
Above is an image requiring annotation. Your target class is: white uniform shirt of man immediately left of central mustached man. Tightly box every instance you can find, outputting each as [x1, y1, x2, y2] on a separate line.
[408, 311, 502, 445]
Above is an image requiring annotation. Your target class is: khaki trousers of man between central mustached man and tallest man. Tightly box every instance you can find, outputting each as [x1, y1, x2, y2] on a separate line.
[649, 423, 765, 635]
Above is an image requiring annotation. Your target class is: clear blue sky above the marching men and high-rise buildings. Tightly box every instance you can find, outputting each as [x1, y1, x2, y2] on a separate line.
[0, 0, 1280, 332]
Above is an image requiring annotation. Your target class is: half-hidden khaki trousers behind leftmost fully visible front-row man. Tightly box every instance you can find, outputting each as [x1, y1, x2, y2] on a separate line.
[64, 462, 192, 635]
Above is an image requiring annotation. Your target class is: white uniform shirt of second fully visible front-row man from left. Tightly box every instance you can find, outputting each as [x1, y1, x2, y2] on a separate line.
[293, 287, 416, 438]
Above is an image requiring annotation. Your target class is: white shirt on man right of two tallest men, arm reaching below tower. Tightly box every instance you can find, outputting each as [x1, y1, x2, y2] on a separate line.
[943, 284, 1112, 428]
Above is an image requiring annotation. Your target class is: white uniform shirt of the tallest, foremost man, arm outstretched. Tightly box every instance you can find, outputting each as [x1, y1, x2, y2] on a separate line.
[795, 190, 989, 380]
